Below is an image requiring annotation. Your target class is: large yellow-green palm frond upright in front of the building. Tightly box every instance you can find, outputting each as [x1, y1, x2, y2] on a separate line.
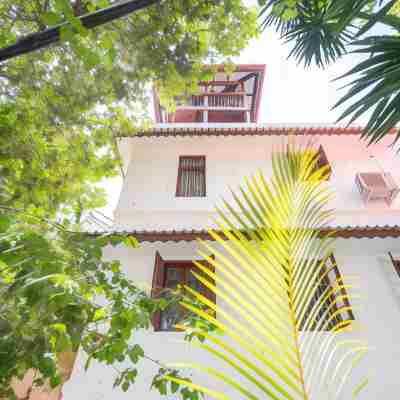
[166, 144, 367, 400]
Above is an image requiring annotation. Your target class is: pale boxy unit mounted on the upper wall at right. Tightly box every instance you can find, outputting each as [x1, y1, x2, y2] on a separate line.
[356, 172, 400, 206]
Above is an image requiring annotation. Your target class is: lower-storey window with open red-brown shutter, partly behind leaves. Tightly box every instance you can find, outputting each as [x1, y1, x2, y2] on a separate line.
[152, 252, 215, 331]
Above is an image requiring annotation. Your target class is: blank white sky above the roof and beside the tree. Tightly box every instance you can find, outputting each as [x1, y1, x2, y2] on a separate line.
[97, 11, 380, 216]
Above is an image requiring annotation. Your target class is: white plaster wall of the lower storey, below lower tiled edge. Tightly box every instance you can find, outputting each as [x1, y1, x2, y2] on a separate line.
[63, 239, 400, 400]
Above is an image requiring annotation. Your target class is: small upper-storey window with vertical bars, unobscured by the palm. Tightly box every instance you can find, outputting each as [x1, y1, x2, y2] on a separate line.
[176, 156, 206, 197]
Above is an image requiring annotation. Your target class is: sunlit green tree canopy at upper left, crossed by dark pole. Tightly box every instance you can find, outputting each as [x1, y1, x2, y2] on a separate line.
[0, 0, 257, 216]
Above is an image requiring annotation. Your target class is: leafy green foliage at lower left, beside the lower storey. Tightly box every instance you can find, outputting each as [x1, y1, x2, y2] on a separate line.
[0, 214, 159, 397]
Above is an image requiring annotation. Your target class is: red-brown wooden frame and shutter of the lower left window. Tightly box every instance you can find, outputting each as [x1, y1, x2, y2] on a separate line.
[151, 251, 216, 332]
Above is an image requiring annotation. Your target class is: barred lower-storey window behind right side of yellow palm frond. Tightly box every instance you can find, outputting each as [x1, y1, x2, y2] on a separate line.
[300, 254, 354, 330]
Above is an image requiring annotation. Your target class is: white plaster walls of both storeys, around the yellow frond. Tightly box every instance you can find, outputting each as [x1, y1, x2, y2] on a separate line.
[63, 128, 400, 400]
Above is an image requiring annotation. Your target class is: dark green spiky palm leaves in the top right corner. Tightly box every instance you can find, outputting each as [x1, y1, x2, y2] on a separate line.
[260, 0, 400, 143]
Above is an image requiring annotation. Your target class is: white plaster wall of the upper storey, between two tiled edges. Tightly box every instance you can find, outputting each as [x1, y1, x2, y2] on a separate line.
[115, 135, 400, 230]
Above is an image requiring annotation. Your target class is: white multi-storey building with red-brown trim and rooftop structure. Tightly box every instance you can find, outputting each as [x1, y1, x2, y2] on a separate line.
[63, 65, 400, 400]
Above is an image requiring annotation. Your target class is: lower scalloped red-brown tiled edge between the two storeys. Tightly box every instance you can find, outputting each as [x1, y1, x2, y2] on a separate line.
[91, 225, 400, 243]
